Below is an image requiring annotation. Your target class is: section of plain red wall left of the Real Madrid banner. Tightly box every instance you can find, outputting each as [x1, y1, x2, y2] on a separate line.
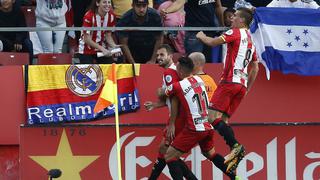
[0, 66, 27, 145]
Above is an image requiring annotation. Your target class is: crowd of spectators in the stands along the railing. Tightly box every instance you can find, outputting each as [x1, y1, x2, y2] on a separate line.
[0, 0, 319, 64]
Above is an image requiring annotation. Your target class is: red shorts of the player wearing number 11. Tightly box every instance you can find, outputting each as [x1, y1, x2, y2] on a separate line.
[171, 128, 214, 153]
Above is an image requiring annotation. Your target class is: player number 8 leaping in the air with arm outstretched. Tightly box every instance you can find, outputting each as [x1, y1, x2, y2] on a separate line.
[197, 8, 259, 171]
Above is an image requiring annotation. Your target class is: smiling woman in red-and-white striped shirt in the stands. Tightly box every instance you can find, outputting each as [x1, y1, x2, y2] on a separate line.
[79, 0, 121, 64]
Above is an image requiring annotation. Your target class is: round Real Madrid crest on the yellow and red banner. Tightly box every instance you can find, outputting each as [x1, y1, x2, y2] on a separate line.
[66, 64, 103, 97]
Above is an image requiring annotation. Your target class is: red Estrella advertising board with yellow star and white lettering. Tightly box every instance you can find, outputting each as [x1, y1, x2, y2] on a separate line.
[20, 125, 320, 180]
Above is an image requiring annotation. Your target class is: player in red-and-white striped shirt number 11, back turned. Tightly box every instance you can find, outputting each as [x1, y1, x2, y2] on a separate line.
[165, 57, 238, 180]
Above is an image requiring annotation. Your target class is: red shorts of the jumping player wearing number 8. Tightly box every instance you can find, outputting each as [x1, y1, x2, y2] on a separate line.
[209, 83, 247, 117]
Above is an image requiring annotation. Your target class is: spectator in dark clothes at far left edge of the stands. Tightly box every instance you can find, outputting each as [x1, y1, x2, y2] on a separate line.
[0, 0, 33, 64]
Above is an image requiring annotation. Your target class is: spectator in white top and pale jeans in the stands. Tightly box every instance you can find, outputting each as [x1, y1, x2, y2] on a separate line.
[35, 0, 68, 53]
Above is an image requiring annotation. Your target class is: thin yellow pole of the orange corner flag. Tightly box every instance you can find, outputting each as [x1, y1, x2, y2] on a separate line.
[112, 64, 122, 180]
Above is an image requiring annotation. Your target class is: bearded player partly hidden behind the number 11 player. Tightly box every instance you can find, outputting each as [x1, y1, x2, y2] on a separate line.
[144, 44, 196, 180]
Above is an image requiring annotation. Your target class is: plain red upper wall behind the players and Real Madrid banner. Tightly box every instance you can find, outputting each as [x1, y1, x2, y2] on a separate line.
[0, 64, 320, 144]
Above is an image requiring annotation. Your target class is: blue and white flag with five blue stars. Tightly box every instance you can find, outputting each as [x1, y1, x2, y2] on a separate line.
[250, 8, 320, 79]
